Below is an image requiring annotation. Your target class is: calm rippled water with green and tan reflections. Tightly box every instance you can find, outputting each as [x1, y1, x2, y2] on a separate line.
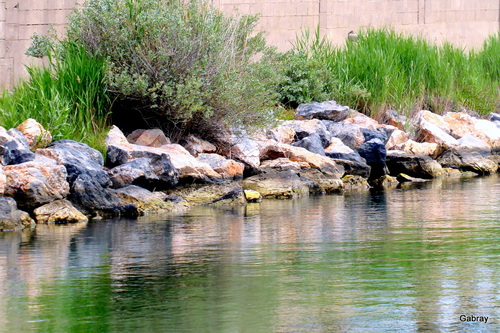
[0, 176, 500, 333]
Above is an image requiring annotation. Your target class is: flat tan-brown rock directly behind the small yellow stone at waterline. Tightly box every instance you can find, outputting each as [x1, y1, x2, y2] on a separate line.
[241, 171, 310, 198]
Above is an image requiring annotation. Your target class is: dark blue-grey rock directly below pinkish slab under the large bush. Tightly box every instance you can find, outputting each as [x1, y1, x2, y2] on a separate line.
[108, 154, 179, 189]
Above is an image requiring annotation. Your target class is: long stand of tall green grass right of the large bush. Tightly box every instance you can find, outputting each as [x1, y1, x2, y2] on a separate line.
[281, 28, 500, 115]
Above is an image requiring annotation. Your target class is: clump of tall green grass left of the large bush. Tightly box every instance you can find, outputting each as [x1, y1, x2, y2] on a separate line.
[0, 42, 111, 151]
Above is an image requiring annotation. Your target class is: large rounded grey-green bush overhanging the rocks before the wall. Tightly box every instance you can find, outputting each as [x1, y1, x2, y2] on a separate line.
[69, 0, 279, 139]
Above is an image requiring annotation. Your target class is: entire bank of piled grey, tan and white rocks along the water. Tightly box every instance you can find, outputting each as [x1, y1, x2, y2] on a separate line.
[0, 101, 500, 231]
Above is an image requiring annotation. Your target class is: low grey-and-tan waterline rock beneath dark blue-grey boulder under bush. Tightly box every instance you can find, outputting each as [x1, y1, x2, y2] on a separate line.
[113, 185, 187, 215]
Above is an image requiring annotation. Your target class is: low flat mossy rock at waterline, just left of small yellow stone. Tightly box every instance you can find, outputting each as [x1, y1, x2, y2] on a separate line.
[181, 183, 246, 206]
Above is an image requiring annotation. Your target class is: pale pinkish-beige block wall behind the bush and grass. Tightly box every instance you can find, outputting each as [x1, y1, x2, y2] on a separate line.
[0, 0, 500, 87]
